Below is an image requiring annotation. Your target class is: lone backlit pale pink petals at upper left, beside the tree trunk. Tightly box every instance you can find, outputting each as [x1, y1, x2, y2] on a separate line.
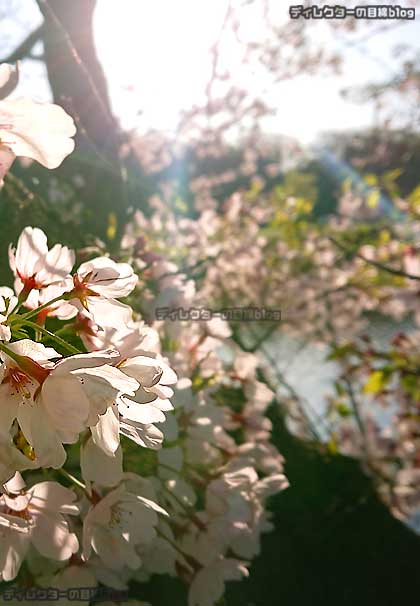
[0, 98, 76, 168]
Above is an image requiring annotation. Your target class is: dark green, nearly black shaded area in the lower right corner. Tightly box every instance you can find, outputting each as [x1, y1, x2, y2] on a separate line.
[134, 410, 420, 606]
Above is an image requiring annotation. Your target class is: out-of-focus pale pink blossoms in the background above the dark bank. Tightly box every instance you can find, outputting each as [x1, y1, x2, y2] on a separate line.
[119, 175, 420, 532]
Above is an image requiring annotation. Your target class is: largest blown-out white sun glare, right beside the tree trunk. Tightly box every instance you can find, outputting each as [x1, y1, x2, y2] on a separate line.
[95, 0, 230, 135]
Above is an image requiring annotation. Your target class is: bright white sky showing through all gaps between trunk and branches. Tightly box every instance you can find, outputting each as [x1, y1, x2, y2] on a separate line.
[0, 0, 420, 143]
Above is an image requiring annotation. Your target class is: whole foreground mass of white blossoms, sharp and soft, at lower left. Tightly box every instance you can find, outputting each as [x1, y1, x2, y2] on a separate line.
[0, 227, 287, 606]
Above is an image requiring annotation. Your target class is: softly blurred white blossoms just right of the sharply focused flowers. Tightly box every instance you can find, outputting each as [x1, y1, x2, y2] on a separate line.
[118, 214, 288, 606]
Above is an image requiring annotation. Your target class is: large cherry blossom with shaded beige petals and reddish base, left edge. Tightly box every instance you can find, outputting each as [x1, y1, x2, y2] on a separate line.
[0, 339, 138, 478]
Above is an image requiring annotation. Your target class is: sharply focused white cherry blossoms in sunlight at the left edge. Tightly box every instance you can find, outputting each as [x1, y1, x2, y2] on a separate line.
[0, 227, 177, 580]
